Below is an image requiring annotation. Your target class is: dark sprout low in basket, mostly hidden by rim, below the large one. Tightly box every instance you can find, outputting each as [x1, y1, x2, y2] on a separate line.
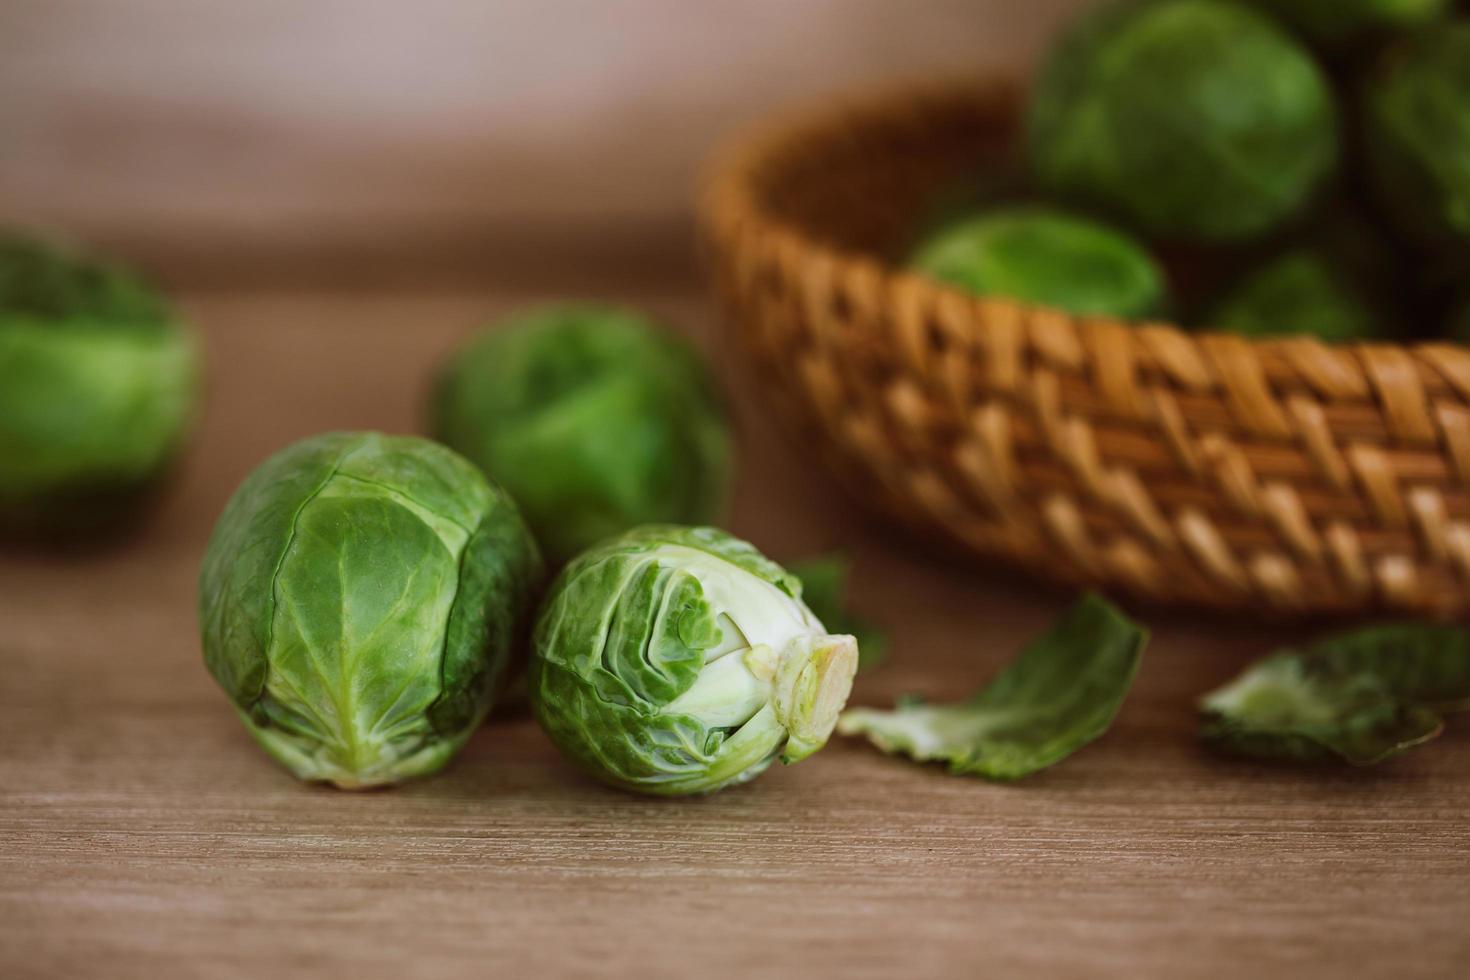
[1208, 248, 1379, 342]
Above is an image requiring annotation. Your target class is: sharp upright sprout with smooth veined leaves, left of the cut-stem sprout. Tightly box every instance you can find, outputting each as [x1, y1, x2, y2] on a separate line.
[198, 432, 541, 789]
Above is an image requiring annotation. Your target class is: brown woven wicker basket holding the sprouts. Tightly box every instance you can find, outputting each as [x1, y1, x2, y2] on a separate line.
[701, 84, 1470, 616]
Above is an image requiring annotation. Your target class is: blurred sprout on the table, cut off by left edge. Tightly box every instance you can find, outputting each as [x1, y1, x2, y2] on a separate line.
[0, 234, 198, 536]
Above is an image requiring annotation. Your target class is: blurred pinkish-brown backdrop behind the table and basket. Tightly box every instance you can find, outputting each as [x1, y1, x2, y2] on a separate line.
[0, 0, 1086, 285]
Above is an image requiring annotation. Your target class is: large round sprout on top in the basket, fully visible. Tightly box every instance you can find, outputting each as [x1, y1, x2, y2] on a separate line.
[1028, 0, 1338, 242]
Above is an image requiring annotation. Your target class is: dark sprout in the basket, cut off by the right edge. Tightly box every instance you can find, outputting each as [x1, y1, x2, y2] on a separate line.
[1366, 21, 1470, 259]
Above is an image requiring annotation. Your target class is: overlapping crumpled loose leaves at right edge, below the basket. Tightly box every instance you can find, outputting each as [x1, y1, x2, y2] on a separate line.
[1201, 623, 1470, 765]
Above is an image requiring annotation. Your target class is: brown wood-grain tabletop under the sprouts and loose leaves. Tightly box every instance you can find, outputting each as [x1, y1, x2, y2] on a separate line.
[0, 279, 1470, 980]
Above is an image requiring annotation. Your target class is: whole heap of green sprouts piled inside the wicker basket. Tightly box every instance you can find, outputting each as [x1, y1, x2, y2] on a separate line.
[908, 0, 1470, 342]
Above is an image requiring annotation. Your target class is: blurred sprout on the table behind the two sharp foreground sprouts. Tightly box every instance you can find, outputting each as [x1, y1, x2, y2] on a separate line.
[432, 304, 731, 564]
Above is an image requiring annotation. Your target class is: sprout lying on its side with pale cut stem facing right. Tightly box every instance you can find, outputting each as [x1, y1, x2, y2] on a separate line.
[531, 526, 857, 796]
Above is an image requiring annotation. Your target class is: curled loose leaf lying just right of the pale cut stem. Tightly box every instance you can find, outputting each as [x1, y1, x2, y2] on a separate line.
[838, 595, 1148, 780]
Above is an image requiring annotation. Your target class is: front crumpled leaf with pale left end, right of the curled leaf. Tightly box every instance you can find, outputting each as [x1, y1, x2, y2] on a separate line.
[1201, 651, 1444, 765]
